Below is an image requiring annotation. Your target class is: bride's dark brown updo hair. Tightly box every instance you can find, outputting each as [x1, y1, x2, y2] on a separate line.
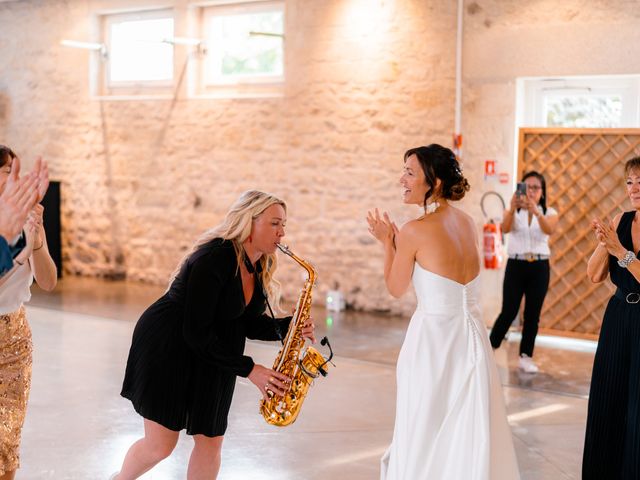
[404, 143, 470, 208]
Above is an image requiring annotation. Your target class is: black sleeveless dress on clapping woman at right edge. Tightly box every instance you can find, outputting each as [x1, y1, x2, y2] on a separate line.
[582, 212, 640, 480]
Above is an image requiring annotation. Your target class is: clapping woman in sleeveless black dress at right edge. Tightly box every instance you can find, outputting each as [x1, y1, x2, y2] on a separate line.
[582, 157, 640, 480]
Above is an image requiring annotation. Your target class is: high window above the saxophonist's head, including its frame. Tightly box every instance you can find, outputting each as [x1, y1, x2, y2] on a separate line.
[199, 1, 284, 93]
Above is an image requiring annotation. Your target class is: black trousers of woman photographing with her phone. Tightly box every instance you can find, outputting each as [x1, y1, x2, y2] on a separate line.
[489, 258, 550, 357]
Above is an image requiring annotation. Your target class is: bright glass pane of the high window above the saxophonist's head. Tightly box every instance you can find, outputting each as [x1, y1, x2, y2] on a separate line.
[207, 11, 284, 83]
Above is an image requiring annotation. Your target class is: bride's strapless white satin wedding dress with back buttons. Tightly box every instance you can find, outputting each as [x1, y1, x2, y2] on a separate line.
[380, 263, 520, 480]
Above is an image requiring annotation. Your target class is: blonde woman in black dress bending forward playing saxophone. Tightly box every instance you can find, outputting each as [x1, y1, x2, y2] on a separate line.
[114, 191, 315, 480]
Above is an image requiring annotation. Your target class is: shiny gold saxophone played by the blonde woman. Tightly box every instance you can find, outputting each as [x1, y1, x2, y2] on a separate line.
[260, 245, 333, 427]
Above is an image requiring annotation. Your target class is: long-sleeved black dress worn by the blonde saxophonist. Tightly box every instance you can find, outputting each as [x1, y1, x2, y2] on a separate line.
[121, 239, 291, 437]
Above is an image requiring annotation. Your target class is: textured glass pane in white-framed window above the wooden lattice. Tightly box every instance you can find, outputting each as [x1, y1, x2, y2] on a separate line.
[544, 95, 622, 128]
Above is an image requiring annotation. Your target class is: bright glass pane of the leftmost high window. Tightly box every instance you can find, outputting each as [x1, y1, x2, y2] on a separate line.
[109, 18, 173, 82]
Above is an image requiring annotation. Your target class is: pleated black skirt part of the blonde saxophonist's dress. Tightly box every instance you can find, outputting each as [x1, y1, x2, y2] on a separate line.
[121, 297, 236, 437]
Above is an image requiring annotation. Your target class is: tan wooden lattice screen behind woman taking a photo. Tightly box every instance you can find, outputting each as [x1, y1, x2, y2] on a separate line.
[518, 128, 640, 338]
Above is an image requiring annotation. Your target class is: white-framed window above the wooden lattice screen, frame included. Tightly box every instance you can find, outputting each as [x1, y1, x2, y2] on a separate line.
[517, 75, 640, 128]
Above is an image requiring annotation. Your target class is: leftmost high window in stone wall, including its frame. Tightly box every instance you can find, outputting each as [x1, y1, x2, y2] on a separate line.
[103, 10, 174, 94]
